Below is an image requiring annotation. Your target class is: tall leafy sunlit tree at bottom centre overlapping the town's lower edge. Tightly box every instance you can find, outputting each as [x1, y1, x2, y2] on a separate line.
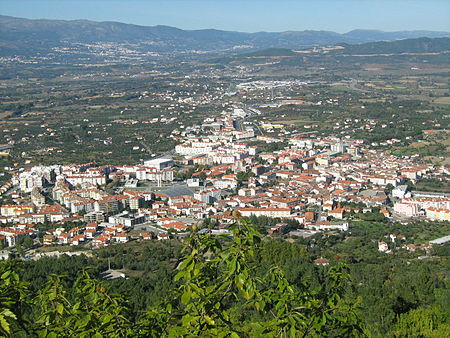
[163, 215, 362, 337]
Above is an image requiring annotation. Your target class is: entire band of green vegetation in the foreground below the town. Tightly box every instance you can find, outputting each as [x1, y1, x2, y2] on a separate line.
[0, 219, 450, 337]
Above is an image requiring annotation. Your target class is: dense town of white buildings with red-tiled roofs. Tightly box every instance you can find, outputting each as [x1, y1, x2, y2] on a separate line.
[0, 108, 450, 258]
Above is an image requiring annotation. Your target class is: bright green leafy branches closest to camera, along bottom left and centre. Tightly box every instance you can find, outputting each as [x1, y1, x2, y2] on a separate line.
[0, 220, 362, 337]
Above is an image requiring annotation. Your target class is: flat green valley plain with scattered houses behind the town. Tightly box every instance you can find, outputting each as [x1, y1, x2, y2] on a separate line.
[0, 39, 450, 173]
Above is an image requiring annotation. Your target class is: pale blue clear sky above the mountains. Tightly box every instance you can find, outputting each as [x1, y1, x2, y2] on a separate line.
[0, 0, 450, 33]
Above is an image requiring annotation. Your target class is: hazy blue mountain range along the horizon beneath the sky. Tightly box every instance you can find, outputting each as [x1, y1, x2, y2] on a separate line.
[0, 16, 450, 56]
